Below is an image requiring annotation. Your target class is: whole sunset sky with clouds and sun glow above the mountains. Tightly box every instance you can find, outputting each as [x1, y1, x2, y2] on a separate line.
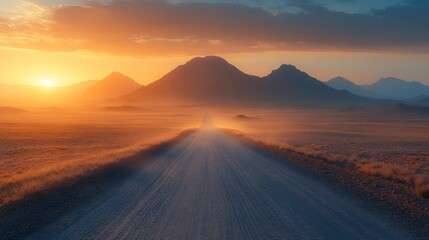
[0, 0, 429, 85]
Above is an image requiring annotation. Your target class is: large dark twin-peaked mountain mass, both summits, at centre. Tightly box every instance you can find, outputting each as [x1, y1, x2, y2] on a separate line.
[117, 56, 371, 105]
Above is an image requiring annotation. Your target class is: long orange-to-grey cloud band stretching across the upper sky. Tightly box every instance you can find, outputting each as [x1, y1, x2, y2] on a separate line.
[0, 0, 429, 57]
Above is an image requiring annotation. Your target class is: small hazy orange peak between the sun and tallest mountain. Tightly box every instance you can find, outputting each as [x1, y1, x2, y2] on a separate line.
[84, 72, 142, 99]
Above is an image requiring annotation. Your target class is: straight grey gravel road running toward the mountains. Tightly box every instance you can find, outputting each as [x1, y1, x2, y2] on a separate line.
[29, 128, 407, 239]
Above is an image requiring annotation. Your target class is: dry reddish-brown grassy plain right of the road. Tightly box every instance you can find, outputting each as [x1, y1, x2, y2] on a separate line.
[215, 109, 429, 197]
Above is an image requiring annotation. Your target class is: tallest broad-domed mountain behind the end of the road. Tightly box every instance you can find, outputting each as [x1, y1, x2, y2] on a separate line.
[121, 57, 260, 103]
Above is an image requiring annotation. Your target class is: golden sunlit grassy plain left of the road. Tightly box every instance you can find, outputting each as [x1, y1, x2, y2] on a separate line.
[0, 109, 202, 205]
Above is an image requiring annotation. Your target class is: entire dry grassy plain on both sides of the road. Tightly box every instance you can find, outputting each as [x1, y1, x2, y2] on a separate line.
[0, 107, 429, 204]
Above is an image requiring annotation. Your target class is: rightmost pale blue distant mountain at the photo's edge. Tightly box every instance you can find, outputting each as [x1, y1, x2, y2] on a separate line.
[365, 77, 429, 99]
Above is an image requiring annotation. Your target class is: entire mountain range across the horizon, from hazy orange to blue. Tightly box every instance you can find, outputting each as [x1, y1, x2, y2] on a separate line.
[0, 56, 429, 106]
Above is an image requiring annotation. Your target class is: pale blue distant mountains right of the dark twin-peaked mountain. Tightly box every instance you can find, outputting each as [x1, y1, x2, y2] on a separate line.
[326, 77, 429, 99]
